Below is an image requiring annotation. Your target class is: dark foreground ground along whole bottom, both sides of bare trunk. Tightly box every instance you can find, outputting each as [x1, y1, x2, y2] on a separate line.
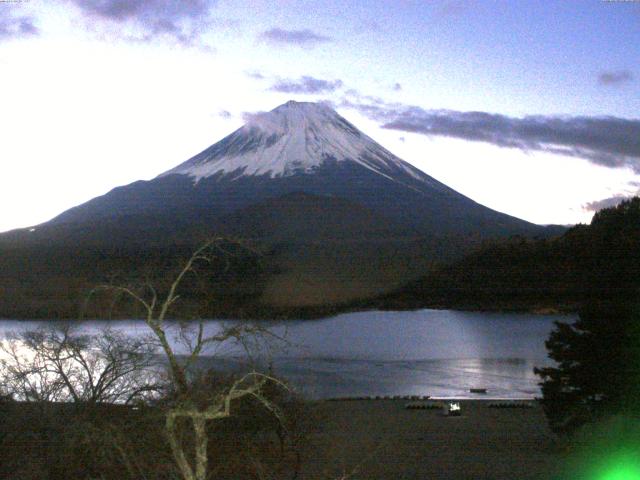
[0, 400, 560, 480]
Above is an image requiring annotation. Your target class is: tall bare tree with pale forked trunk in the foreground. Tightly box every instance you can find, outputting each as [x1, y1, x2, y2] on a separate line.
[98, 242, 286, 480]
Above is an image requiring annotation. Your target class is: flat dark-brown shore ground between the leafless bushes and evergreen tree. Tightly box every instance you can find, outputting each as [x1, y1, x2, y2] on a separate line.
[302, 400, 561, 480]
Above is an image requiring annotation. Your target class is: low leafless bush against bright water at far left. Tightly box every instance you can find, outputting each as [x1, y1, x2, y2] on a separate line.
[0, 324, 161, 404]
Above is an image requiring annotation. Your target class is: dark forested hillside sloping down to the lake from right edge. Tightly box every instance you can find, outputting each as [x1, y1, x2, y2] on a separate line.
[375, 197, 640, 311]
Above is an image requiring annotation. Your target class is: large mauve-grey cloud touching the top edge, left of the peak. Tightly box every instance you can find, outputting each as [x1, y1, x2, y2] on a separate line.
[69, 0, 216, 49]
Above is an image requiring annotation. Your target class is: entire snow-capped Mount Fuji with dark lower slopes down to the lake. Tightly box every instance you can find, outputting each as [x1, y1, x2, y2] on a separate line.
[0, 101, 556, 318]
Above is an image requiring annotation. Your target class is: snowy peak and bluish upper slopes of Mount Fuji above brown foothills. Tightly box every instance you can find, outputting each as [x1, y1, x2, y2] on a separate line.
[43, 101, 543, 241]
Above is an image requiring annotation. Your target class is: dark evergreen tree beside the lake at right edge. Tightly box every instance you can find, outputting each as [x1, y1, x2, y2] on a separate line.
[535, 295, 640, 434]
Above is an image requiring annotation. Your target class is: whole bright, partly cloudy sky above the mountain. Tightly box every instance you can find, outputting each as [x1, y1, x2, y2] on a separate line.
[0, 0, 640, 231]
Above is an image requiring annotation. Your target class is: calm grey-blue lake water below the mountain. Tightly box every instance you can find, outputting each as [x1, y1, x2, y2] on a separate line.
[0, 310, 575, 399]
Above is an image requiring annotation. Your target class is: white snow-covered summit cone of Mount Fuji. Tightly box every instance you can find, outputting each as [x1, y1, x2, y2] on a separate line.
[160, 101, 440, 187]
